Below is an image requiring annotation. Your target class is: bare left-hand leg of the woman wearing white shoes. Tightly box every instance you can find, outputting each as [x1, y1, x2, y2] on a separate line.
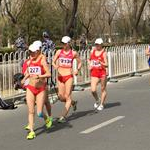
[91, 77, 99, 102]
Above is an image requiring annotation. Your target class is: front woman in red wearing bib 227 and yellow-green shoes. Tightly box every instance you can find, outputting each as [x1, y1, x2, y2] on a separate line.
[22, 42, 52, 139]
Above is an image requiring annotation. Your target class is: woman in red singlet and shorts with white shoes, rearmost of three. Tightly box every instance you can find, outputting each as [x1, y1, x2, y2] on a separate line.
[89, 38, 108, 110]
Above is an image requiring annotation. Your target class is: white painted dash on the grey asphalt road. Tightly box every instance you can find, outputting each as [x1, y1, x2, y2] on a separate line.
[80, 116, 125, 134]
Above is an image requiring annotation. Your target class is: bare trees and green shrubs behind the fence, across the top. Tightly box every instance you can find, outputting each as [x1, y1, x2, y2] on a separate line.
[0, 0, 150, 47]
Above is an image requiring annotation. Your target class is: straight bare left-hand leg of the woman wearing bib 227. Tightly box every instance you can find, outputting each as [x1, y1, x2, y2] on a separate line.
[26, 88, 35, 131]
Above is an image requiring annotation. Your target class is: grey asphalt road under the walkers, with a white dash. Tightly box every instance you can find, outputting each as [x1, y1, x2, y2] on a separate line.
[0, 75, 150, 150]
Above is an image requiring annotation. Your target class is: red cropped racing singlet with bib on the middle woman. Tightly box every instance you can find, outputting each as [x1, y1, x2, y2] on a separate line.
[58, 49, 74, 68]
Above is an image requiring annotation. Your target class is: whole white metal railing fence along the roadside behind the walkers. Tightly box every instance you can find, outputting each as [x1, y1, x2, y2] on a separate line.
[0, 44, 149, 98]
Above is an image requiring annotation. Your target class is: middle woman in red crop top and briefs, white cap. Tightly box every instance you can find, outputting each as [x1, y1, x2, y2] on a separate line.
[52, 36, 81, 123]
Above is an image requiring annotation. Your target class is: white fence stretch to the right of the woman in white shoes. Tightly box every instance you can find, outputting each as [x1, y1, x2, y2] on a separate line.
[107, 44, 149, 78]
